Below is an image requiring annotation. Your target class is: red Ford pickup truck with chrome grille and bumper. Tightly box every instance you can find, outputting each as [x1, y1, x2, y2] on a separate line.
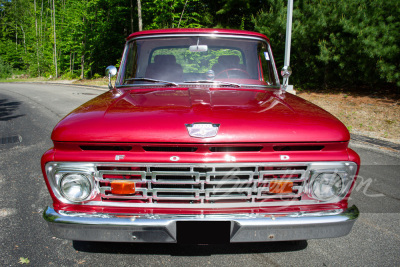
[41, 29, 360, 243]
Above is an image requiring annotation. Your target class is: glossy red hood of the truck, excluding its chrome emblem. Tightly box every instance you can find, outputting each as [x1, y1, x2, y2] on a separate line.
[52, 87, 350, 143]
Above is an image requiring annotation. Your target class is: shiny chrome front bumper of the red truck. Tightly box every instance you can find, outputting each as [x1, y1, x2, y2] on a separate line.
[43, 206, 359, 243]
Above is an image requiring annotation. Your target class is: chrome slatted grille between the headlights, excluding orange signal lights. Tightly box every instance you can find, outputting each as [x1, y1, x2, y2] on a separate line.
[95, 163, 308, 204]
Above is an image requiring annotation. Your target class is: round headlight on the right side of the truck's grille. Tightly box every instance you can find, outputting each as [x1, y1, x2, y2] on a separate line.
[312, 173, 343, 201]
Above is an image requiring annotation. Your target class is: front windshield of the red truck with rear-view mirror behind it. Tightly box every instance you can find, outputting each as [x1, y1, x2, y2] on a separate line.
[117, 35, 277, 86]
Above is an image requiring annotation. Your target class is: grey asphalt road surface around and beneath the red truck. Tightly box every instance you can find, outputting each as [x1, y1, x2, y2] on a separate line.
[0, 84, 400, 266]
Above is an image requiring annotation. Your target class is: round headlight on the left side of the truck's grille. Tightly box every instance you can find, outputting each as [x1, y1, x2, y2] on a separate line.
[60, 173, 92, 202]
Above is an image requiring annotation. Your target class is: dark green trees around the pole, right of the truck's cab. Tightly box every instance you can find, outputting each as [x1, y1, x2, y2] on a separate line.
[253, 0, 400, 87]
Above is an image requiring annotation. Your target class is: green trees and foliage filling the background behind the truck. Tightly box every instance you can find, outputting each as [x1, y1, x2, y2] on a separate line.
[0, 0, 400, 91]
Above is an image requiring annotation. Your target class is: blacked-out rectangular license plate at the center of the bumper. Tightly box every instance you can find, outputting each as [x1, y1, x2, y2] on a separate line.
[176, 221, 231, 244]
